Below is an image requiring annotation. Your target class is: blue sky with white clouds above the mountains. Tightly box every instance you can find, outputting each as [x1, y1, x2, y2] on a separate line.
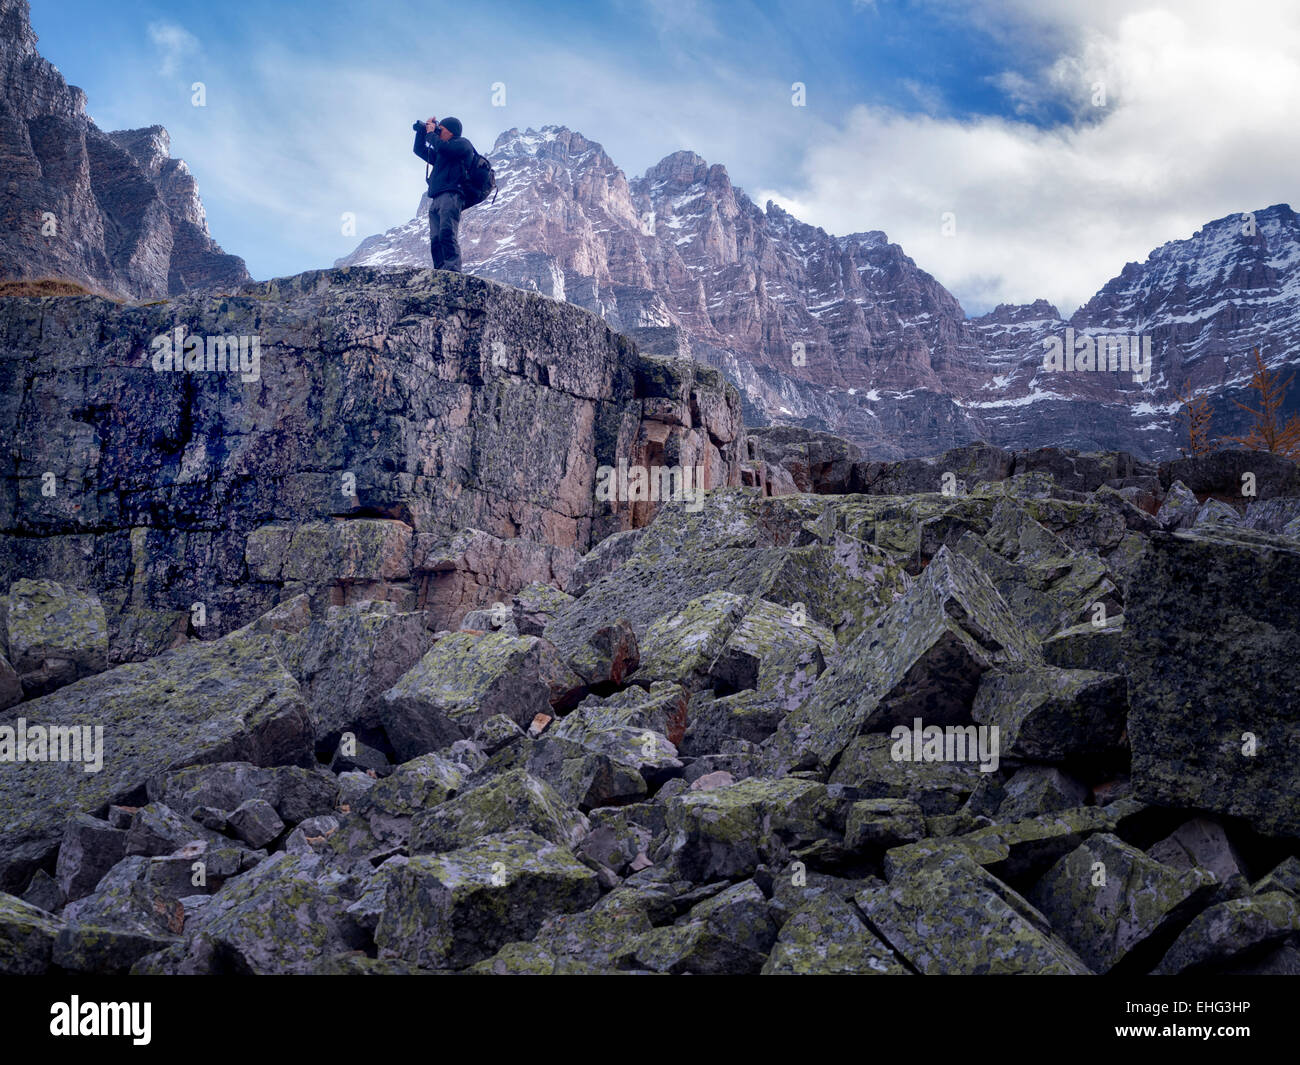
[31, 0, 1300, 313]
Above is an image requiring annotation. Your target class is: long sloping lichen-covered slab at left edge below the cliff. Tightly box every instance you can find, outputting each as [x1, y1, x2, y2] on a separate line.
[0, 633, 313, 888]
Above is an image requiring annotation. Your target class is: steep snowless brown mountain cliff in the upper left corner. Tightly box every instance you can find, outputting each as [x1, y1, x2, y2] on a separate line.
[0, 0, 248, 298]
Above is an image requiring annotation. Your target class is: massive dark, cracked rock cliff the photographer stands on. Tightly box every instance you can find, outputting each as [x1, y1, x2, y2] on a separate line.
[0, 269, 745, 661]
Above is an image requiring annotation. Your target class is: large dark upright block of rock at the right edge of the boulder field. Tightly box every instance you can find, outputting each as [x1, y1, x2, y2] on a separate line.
[1125, 528, 1300, 836]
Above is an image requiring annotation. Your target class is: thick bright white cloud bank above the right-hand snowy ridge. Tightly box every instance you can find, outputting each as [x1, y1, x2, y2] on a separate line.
[755, 0, 1300, 313]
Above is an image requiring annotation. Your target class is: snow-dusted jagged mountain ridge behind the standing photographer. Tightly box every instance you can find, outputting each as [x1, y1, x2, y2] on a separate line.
[338, 126, 1300, 458]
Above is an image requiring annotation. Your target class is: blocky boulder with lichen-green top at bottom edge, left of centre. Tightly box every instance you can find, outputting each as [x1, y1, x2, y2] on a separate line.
[374, 831, 601, 969]
